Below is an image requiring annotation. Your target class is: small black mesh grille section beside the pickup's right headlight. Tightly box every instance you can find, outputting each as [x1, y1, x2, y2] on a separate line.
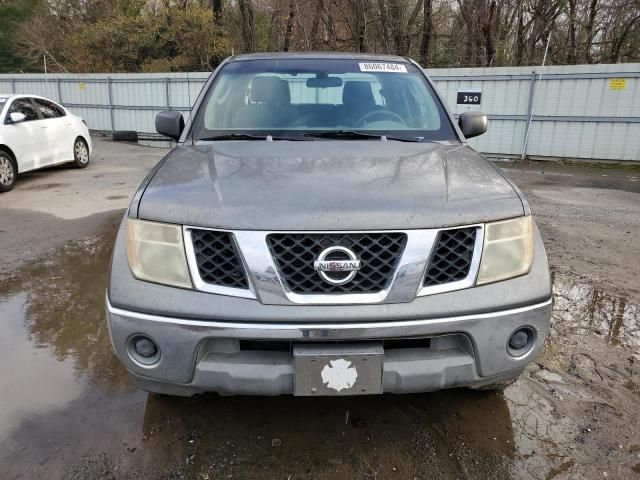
[424, 227, 476, 287]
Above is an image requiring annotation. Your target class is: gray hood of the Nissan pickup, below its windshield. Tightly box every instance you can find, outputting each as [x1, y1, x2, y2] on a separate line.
[134, 140, 524, 230]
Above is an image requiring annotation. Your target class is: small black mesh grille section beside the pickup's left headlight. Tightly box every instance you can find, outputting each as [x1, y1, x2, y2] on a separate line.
[191, 229, 249, 289]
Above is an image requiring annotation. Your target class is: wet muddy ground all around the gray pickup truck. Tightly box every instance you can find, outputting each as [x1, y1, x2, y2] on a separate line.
[0, 140, 640, 480]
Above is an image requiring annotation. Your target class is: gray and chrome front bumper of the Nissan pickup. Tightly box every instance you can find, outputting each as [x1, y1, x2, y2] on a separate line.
[107, 298, 551, 395]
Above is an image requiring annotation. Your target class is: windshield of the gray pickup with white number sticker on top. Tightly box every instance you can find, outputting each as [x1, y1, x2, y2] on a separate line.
[193, 58, 457, 141]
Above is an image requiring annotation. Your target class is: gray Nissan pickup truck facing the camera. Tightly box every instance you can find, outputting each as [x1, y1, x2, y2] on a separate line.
[106, 53, 551, 396]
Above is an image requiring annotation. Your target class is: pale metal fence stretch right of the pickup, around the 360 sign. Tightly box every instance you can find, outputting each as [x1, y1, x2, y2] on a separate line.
[429, 63, 640, 161]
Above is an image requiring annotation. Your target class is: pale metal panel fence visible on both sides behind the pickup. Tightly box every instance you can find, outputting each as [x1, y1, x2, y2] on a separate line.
[0, 64, 640, 161]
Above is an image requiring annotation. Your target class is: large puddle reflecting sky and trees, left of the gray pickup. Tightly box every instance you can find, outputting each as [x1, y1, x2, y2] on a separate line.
[0, 229, 146, 480]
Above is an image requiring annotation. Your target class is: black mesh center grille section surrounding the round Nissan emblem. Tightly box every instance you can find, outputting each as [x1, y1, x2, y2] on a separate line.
[267, 232, 407, 294]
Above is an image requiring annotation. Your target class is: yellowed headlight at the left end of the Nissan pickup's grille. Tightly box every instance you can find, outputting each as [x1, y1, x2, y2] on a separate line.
[127, 219, 192, 288]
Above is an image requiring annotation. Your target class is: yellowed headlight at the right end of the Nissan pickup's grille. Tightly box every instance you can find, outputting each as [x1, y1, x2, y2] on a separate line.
[476, 215, 533, 285]
